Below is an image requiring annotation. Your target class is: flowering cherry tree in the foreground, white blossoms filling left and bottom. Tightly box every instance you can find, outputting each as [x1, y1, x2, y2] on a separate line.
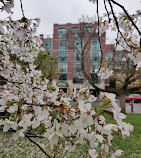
[0, 0, 133, 158]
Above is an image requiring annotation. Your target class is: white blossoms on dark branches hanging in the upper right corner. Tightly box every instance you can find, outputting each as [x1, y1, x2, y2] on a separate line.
[99, 11, 141, 69]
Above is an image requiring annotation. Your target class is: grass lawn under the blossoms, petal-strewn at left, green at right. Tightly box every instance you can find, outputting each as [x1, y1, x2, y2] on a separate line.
[0, 114, 141, 158]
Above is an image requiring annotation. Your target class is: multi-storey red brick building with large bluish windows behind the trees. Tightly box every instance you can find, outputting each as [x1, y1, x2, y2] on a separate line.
[40, 23, 134, 96]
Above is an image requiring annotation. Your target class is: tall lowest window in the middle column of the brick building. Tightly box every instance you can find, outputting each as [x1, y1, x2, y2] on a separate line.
[73, 63, 83, 83]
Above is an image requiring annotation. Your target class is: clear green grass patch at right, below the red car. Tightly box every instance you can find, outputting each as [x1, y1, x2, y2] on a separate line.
[113, 114, 141, 158]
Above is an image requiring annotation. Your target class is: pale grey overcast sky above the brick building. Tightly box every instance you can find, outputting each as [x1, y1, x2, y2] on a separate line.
[1, 0, 141, 35]
